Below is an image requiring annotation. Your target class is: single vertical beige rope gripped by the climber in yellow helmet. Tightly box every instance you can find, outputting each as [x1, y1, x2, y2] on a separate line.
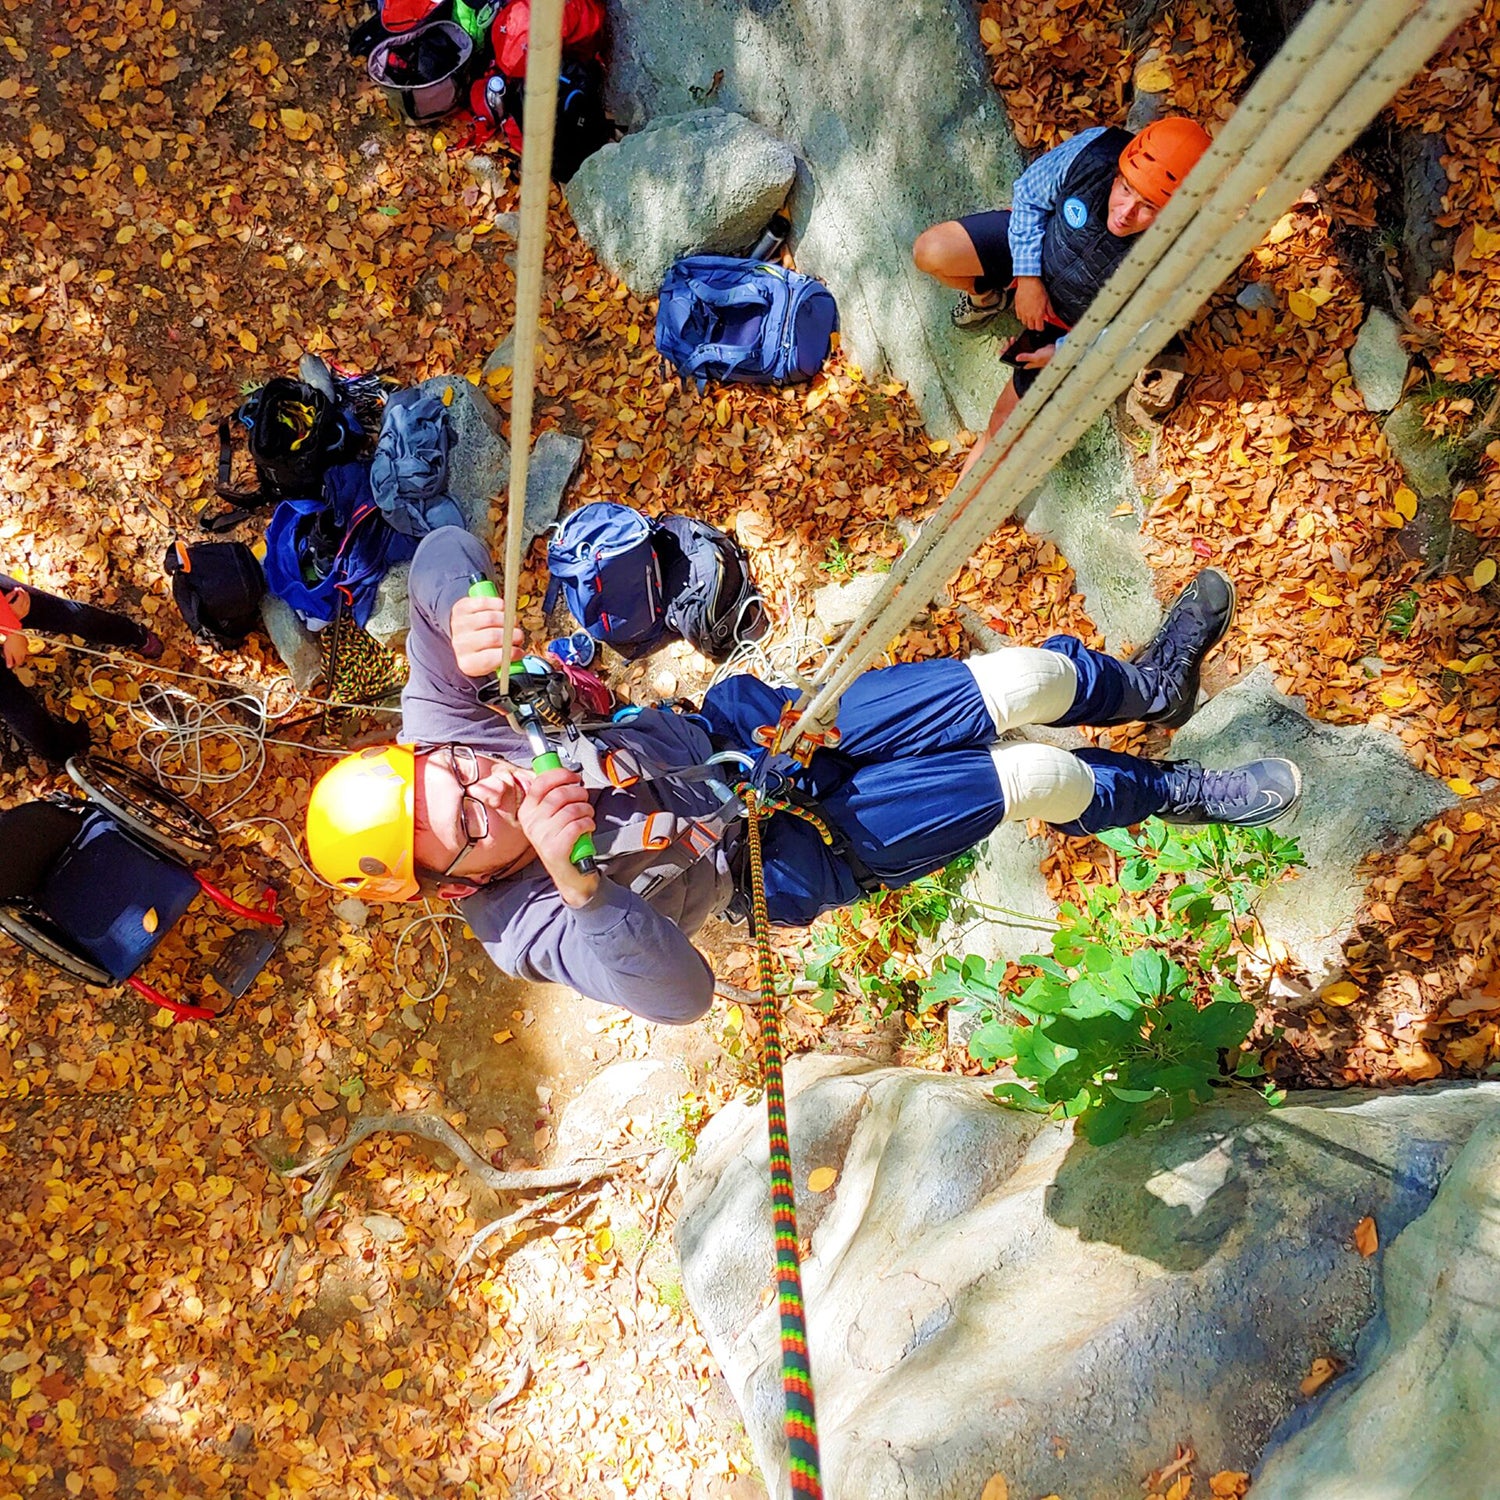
[497, 0, 563, 692]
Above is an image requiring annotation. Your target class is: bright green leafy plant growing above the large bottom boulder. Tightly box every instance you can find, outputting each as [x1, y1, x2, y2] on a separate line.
[921, 819, 1304, 1143]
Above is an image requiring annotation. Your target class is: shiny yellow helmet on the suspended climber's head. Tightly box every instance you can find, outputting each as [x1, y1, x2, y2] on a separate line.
[308, 746, 420, 902]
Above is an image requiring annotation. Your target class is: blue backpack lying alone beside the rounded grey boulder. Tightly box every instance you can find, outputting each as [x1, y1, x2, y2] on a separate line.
[656, 255, 839, 390]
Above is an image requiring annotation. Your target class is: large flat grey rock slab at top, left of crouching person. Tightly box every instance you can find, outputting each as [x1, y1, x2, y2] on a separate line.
[603, 0, 1023, 435]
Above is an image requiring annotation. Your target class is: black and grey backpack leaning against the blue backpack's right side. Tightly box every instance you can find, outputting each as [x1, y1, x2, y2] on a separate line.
[654, 516, 771, 662]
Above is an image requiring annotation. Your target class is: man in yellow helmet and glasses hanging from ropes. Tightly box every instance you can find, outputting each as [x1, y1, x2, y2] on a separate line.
[308, 527, 1301, 1023]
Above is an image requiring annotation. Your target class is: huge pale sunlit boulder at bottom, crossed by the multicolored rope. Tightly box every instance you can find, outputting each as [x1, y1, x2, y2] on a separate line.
[677, 1058, 1500, 1500]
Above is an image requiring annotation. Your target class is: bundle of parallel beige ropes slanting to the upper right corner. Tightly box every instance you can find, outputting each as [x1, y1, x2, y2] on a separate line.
[788, 0, 1476, 743]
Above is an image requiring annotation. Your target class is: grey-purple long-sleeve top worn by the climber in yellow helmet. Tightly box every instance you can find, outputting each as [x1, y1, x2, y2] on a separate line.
[402, 527, 734, 1023]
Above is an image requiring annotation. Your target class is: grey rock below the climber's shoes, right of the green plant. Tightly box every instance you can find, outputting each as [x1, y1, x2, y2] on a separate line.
[1172, 663, 1457, 983]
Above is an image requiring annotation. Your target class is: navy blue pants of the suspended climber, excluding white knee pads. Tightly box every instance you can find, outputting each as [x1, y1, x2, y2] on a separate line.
[704, 636, 1167, 926]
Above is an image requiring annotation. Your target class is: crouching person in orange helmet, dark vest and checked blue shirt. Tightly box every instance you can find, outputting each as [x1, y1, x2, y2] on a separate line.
[912, 116, 1209, 477]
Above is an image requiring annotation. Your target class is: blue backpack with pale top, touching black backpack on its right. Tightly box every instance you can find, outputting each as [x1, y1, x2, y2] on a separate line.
[543, 500, 669, 659]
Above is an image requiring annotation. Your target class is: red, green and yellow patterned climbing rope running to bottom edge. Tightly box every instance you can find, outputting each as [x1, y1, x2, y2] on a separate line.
[738, 785, 833, 1500]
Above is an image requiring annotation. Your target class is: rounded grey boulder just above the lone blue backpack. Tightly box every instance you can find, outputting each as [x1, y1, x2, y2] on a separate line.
[567, 110, 797, 297]
